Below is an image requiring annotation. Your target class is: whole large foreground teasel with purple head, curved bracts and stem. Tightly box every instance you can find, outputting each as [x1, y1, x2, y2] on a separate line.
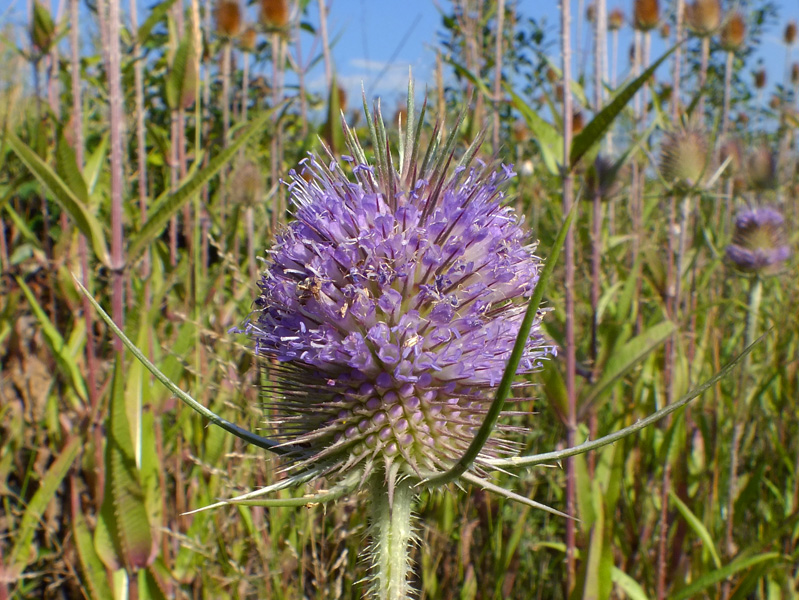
[70, 71, 764, 600]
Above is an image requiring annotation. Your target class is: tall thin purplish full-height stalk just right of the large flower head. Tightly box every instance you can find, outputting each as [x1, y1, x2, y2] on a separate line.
[560, 0, 577, 595]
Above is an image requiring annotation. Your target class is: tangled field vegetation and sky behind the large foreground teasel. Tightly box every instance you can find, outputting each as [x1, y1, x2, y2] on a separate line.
[0, 0, 799, 600]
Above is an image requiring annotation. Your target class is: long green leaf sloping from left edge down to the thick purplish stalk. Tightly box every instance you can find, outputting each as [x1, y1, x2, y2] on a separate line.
[6, 131, 108, 265]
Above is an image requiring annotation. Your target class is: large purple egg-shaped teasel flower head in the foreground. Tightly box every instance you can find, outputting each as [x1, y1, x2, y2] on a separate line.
[238, 94, 553, 490]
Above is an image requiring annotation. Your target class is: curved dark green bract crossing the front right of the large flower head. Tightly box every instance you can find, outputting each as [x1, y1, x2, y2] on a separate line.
[425, 205, 577, 486]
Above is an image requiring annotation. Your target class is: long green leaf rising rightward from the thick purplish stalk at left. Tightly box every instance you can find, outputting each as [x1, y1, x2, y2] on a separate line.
[128, 108, 275, 264]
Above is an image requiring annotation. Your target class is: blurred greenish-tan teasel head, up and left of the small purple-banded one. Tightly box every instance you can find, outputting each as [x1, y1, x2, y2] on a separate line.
[660, 128, 708, 189]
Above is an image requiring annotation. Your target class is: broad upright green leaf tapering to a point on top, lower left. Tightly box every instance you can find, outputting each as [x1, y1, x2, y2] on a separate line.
[101, 357, 153, 569]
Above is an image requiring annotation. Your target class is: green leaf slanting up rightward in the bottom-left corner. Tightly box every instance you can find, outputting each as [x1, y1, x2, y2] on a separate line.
[6, 437, 81, 580]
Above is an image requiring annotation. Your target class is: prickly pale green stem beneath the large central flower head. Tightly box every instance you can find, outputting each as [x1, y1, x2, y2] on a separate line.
[370, 473, 415, 600]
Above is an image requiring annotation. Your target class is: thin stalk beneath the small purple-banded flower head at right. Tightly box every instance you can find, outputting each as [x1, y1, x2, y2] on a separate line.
[721, 276, 763, 600]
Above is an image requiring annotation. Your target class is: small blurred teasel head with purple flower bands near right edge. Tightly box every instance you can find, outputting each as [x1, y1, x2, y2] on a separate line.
[726, 207, 791, 275]
